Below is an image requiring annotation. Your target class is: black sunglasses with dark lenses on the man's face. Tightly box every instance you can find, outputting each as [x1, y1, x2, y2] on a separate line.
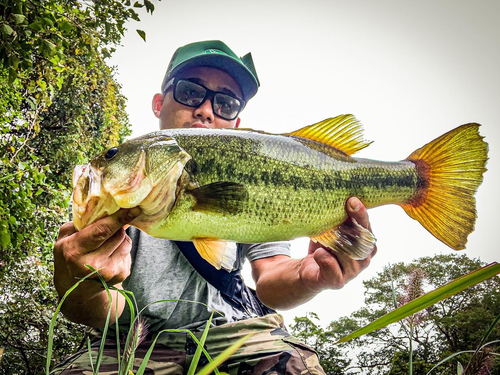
[164, 78, 245, 120]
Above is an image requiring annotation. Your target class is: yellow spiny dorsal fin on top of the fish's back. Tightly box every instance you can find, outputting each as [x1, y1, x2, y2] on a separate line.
[289, 115, 372, 155]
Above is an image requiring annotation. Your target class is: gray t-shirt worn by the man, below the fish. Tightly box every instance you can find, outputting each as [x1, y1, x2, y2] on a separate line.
[120, 227, 290, 331]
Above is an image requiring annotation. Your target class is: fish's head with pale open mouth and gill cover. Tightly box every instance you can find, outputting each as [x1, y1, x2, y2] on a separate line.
[72, 132, 190, 230]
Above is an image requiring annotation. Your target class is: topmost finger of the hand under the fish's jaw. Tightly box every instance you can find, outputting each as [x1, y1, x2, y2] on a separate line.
[75, 207, 141, 252]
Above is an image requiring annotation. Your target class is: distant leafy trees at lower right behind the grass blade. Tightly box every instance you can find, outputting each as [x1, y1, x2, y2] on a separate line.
[292, 254, 500, 375]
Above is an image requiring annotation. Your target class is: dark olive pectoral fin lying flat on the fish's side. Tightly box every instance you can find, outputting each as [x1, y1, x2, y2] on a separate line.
[188, 181, 248, 214]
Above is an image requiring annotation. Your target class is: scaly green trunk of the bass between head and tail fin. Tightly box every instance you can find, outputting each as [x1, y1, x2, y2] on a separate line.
[148, 129, 418, 243]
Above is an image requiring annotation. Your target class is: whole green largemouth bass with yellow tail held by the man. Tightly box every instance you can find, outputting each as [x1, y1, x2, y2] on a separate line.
[72, 115, 488, 270]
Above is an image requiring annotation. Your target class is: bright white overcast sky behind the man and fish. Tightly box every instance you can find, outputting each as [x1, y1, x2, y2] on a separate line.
[111, 0, 500, 326]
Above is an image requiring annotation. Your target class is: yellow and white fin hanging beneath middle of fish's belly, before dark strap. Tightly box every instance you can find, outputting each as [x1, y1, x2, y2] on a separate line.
[192, 237, 236, 271]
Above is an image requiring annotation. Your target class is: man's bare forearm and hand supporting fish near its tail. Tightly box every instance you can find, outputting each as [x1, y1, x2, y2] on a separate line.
[252, 198, 377, 309]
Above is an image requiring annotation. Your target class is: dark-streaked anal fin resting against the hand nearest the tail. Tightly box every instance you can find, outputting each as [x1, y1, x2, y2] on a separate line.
[311, 219, 377, 260]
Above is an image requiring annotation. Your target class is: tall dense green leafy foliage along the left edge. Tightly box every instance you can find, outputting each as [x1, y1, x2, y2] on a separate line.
[0, 0, 158, 373]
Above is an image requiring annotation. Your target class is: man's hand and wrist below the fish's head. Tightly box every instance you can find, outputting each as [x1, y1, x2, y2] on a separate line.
[54, 208, 140, 328]
